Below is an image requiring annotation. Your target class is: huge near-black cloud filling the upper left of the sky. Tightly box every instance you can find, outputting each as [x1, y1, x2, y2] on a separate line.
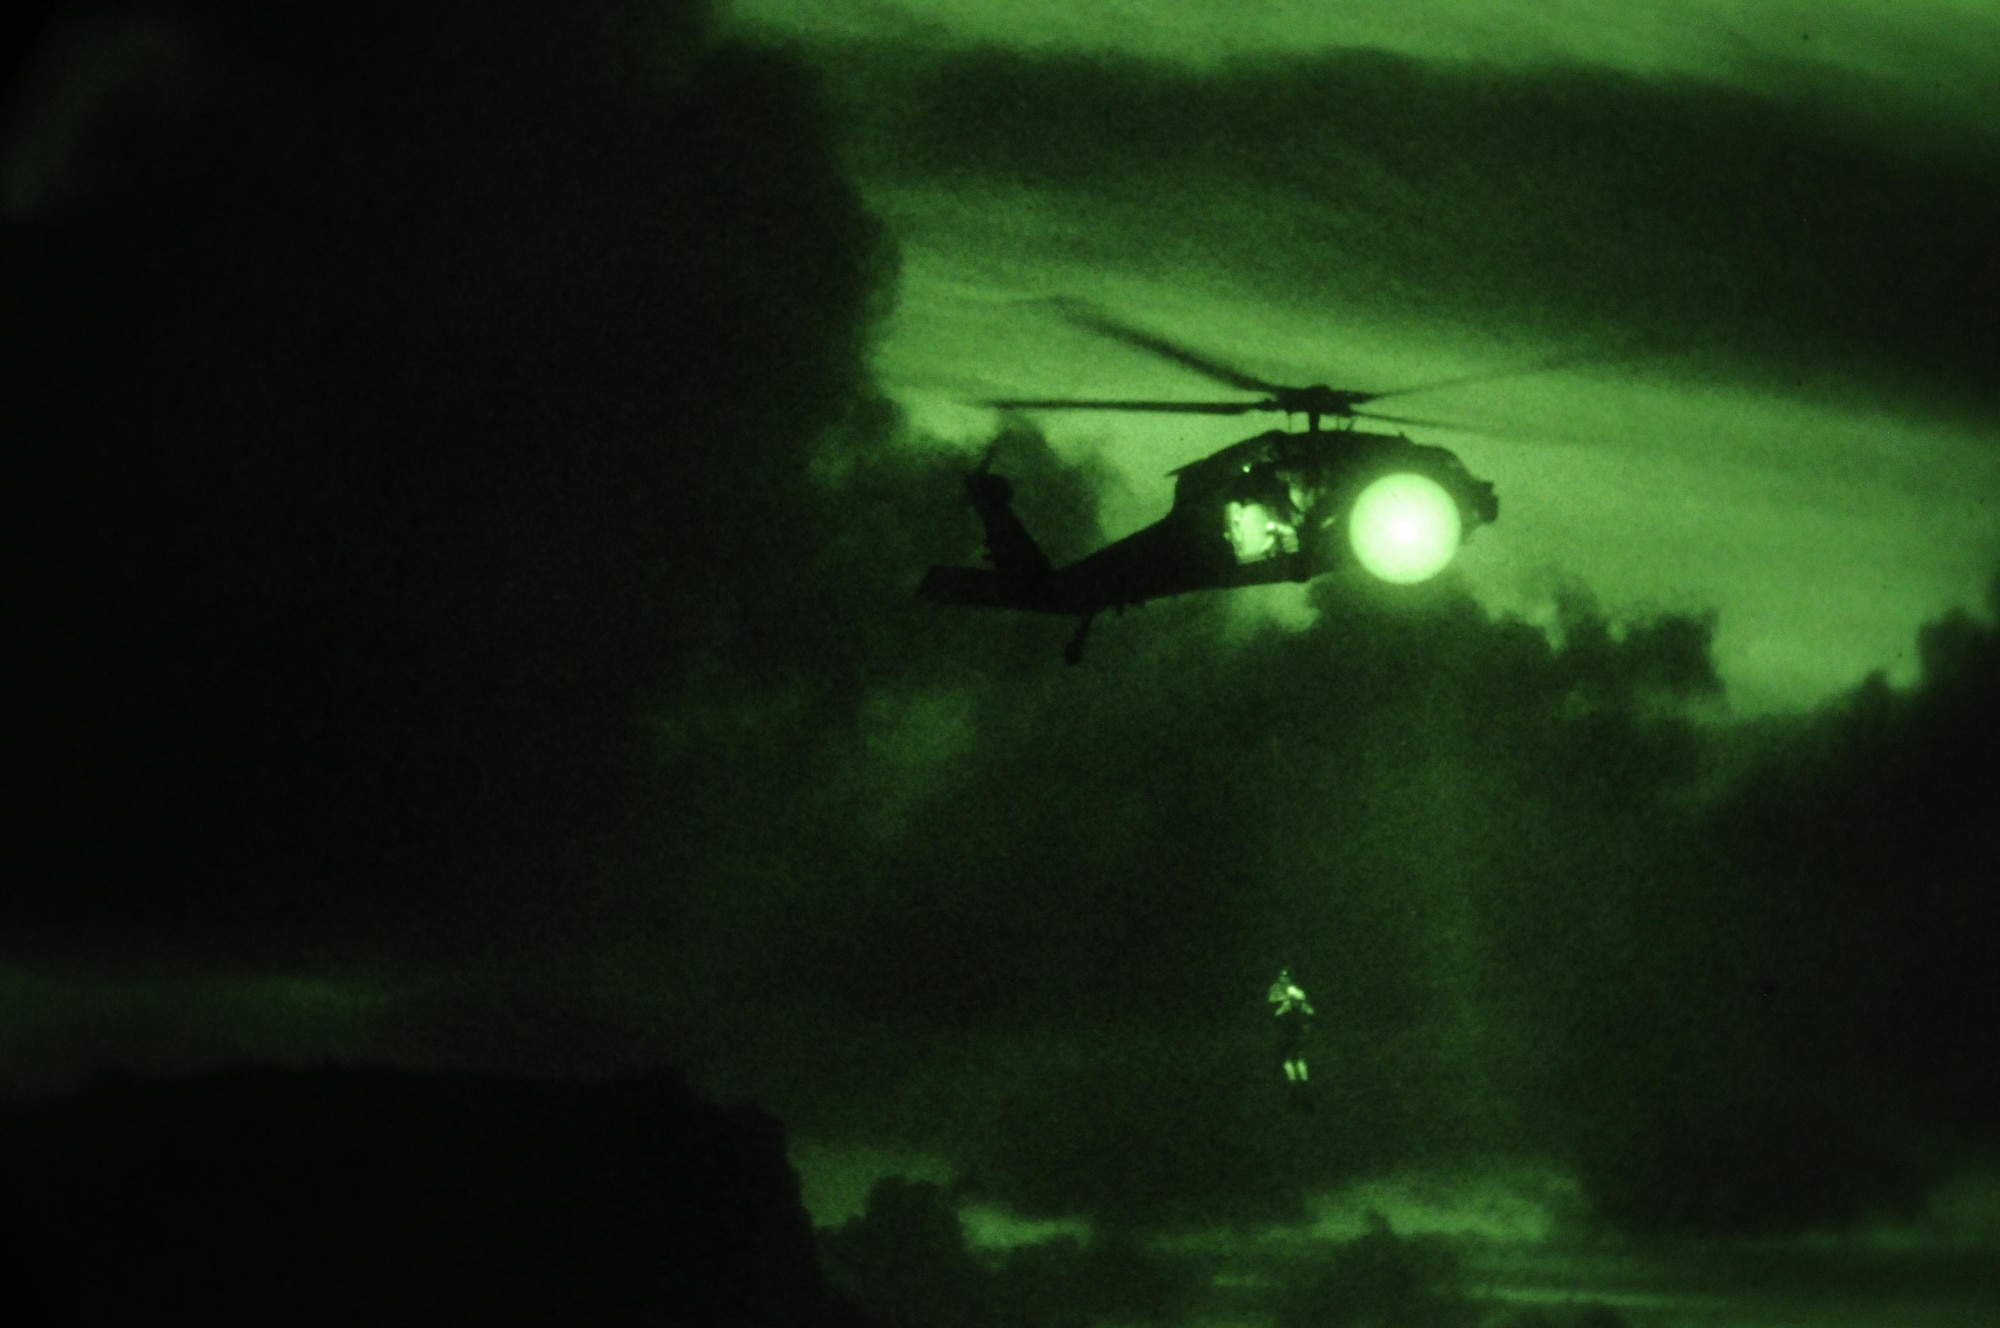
[4, 4, 890, 952]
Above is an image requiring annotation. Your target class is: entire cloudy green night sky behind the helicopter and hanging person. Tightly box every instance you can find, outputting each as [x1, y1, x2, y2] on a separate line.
[0, 0, 2000, 1328]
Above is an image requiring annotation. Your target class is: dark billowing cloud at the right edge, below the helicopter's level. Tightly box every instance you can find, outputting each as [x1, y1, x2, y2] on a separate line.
[1504, 580, 2000, 1230]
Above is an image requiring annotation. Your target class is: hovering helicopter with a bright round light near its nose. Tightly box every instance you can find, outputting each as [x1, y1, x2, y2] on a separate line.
[916, 306, 1504, 664]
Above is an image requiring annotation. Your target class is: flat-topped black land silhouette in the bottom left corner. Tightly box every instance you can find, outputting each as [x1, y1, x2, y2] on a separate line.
[0, 1066, 866, 1328]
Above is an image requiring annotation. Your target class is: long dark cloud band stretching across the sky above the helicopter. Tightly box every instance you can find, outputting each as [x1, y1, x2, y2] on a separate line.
[826, 48, 2000, 410]
